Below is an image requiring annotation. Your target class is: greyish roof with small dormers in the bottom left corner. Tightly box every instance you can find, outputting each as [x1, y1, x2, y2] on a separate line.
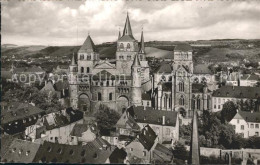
[2, 139, 40, 163]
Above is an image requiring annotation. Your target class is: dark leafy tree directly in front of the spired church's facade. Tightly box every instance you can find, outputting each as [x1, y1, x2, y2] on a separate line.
[94, 105, 120, 134]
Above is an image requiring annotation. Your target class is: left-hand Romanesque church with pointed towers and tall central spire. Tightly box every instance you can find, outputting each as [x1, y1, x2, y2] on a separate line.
[69, 14, 150, 113]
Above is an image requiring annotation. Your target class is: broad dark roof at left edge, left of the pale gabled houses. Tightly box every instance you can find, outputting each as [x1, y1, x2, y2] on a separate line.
[1, 103, 45, 124]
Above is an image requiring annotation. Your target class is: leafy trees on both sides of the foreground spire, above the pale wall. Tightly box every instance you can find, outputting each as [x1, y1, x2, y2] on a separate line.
[180, 111, 260, 149]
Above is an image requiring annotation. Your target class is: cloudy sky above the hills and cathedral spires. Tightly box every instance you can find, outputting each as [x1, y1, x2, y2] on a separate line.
[1, 0, 260, 45]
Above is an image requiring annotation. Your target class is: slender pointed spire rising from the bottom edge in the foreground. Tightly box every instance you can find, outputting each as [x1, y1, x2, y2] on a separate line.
[189, 110, 200, 165]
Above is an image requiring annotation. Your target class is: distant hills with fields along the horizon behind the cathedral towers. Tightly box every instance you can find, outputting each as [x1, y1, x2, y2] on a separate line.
[1, 39, 260, 62]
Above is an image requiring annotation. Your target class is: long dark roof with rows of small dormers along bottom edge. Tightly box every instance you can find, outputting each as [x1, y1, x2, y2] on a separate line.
[34, 141, 114, 164]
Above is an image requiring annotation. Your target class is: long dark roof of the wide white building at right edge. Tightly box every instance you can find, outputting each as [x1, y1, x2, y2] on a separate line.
[212, 86, 260, 99]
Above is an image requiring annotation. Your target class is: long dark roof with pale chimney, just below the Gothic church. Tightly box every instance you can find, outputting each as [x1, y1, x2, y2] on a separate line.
[127, 106, 178, 126]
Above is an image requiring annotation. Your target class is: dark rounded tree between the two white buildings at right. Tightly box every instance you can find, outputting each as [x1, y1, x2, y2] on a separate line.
[221, 101, 237, 122]
